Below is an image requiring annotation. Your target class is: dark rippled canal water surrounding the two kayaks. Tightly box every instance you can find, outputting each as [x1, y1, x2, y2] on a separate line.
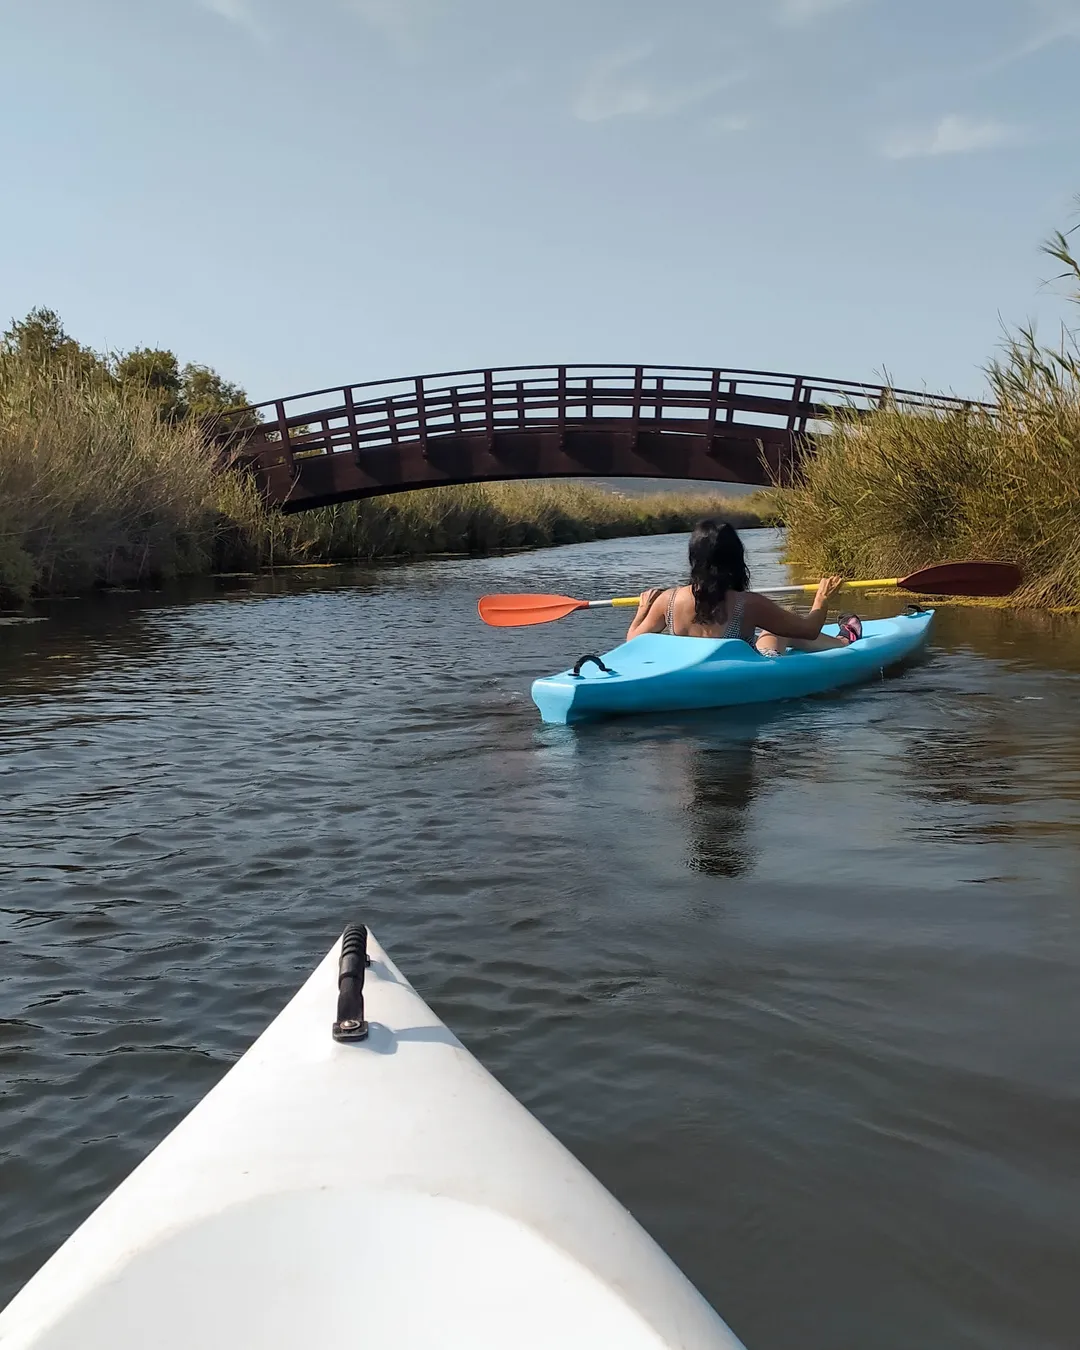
[0, 532, 1080, 1350]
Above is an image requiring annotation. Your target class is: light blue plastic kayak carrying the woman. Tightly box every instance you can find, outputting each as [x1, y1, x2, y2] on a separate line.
[532, 609, 934, 722]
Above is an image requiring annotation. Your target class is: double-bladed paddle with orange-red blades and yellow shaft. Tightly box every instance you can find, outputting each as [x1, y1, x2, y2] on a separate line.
[477, 562, 1023, 628]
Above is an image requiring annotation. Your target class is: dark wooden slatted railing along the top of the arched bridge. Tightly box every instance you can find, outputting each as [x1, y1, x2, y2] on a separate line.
[224, 365, 993, 475]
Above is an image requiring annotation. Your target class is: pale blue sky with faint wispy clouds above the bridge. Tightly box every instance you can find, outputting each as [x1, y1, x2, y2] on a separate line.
[0, 0, 1080, 400]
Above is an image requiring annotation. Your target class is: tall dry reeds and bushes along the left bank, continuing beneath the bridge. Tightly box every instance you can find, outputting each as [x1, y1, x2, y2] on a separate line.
[0, 309, 779, 605]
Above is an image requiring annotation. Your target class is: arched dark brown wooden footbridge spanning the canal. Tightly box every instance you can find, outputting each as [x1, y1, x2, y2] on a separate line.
[223, 366, 967, 512]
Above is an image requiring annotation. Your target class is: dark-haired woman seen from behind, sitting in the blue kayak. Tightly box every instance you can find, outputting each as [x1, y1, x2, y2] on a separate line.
[626, 520, 863, 656]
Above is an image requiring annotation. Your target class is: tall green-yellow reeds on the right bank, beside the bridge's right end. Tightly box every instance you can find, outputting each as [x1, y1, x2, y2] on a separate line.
[786, 211, 1080, 608]
